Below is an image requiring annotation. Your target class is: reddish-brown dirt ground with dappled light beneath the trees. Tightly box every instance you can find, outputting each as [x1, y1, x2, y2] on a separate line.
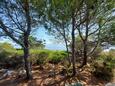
[0, 64, 115, 86]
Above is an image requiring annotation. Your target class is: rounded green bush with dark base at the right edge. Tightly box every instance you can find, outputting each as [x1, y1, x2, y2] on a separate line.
[93, 51, 115, 81]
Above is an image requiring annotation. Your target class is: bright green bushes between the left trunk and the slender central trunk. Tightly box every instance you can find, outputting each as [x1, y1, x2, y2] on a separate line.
[29, 49, 67, 65]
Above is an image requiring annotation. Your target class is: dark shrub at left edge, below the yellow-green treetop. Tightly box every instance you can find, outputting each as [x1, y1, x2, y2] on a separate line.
[0, 51, 23, 68]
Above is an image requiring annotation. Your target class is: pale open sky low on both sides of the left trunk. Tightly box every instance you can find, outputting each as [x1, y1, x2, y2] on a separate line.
[0, 27, 66, 50]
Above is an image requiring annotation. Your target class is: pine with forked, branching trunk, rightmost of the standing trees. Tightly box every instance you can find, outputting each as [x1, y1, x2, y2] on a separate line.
[76, 0, 113, 68]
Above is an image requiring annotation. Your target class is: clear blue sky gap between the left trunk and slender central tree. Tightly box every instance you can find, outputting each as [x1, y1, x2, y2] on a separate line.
[32, 27, 65, 50]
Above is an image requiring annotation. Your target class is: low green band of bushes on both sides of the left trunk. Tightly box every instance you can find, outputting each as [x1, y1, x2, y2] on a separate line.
[0, 45, 67, 67]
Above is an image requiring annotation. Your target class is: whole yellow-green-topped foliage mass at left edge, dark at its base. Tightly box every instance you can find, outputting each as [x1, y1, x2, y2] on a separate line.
[0, 43, 22, 68]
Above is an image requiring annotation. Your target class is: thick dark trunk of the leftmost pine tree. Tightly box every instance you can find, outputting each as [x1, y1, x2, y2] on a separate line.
[23, 0, 32, 79]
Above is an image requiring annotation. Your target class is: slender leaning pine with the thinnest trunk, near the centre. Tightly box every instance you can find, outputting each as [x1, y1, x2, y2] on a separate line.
[44, 0, 71, 66]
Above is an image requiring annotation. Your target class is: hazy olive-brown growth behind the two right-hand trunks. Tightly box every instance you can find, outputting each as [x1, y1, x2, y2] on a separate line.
[70, 36, 102, 64]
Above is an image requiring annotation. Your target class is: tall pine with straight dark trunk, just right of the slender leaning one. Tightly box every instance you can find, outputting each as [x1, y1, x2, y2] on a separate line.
[42, 0, 83, 75]
